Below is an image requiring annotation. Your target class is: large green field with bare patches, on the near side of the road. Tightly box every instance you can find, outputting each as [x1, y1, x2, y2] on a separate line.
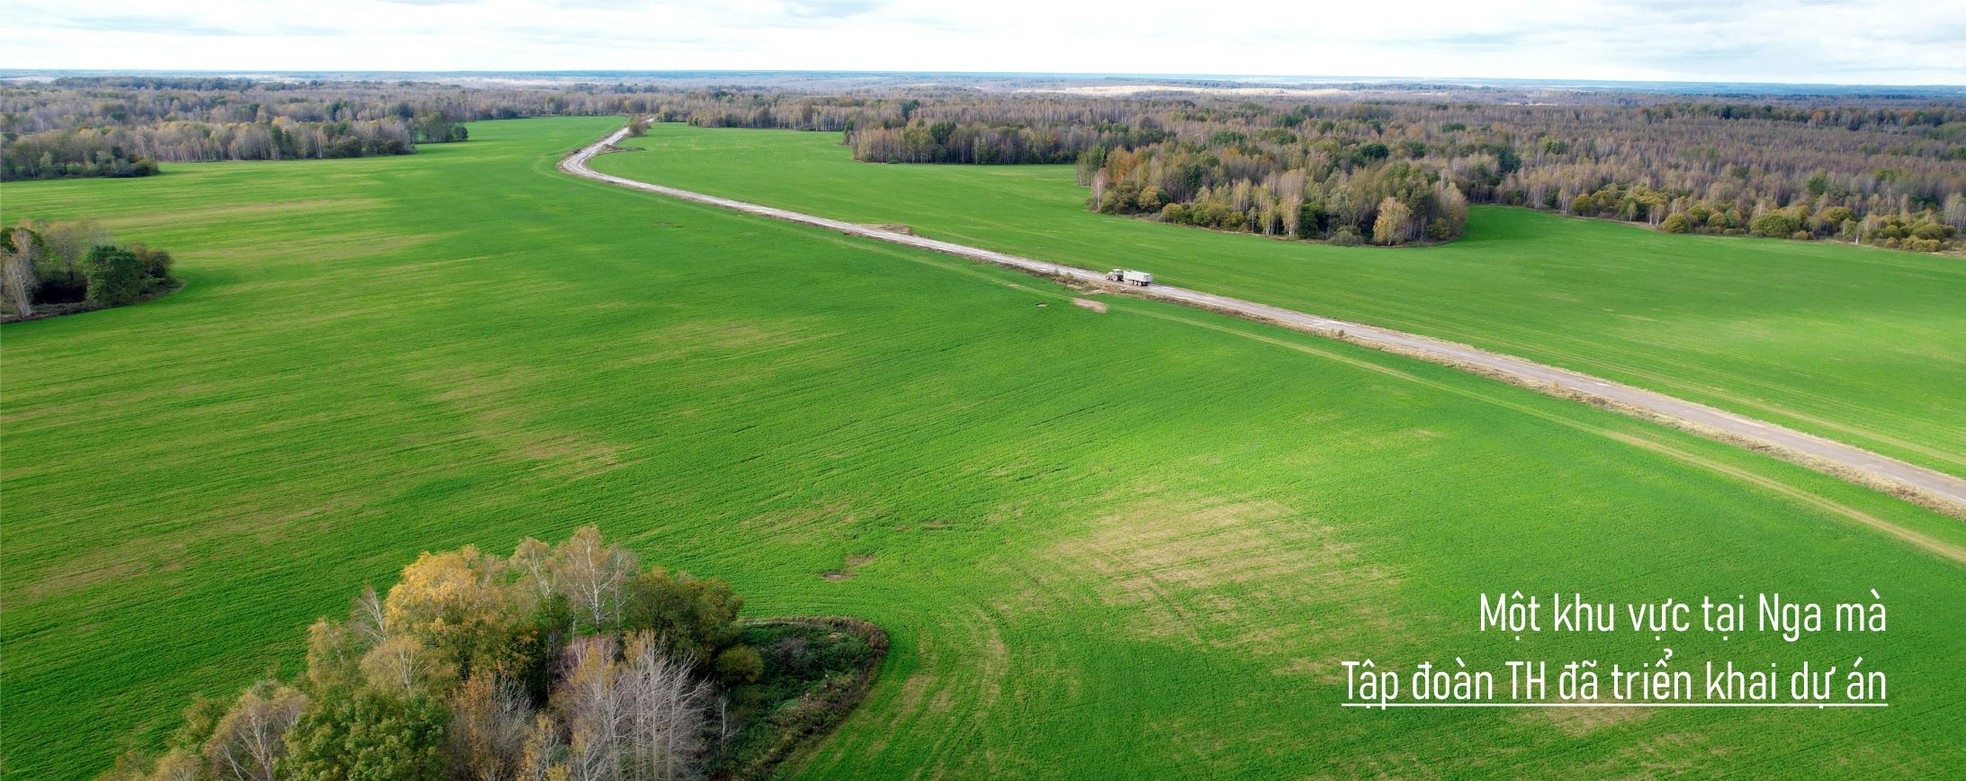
[0, 118, 1966, 779]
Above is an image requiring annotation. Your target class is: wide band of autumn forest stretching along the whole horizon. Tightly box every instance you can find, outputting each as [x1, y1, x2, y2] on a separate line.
[0, 77, 1966, 252]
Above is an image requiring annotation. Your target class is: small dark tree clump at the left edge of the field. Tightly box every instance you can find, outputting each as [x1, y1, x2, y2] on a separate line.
[0, 218, 177, 321]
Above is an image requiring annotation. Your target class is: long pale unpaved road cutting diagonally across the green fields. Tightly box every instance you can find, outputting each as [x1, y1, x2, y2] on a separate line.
[560, 128, 1966, 517]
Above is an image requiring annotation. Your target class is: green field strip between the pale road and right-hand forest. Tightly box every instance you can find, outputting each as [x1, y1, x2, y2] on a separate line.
[596, 124, 1966, 474]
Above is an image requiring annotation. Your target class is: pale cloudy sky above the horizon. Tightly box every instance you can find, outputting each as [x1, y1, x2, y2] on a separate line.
[11, 0, 1966, 85]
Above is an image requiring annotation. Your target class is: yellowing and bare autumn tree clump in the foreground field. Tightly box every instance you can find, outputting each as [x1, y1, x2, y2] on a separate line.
[106, 527, 885, 781]
